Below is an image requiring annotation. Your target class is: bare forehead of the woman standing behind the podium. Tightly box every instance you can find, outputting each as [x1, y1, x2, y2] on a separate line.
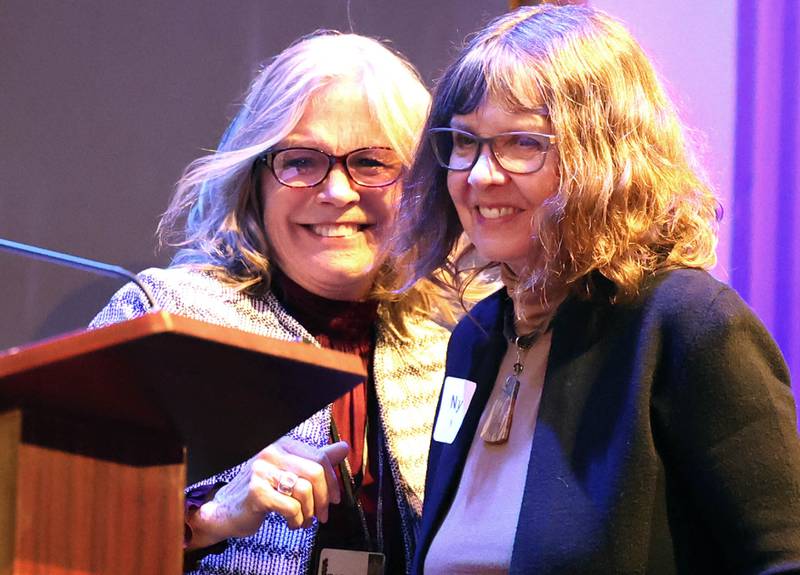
[281, 80, 389, 155]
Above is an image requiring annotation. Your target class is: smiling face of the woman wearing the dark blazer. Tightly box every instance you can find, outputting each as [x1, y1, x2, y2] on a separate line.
[447, 99, 559, 273]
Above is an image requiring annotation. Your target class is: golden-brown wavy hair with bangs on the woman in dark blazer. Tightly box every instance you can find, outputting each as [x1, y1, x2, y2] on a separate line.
[398, 5, 721, 301]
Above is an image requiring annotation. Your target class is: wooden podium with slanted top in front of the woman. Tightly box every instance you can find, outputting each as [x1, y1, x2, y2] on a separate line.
[0, 312, 366, 575]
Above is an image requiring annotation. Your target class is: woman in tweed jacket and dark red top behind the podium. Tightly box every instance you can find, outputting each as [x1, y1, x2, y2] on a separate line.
[93, 32, 449, 575]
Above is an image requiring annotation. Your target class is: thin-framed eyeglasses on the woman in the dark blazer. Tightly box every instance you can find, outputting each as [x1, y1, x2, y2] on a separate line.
[428, 128, 556, 174]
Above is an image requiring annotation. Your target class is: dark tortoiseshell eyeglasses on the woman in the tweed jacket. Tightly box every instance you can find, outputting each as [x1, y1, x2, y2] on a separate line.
[256, 148, 403, 188]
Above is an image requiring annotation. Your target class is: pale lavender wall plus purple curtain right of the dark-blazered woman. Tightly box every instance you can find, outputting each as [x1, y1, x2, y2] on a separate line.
[590, 0, 800, 404]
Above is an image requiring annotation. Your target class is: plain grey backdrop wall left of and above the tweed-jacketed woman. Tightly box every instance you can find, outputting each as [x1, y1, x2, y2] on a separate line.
[0, 0, 507, 349]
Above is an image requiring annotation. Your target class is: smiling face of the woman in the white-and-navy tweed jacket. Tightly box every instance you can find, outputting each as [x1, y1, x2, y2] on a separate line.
[261, 81, 400, 301]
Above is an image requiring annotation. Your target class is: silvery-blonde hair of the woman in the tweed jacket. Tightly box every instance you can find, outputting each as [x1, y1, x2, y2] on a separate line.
[158, 30, 450, 335]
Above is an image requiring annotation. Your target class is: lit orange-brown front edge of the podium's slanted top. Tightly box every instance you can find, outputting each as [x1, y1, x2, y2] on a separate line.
[0, 310, 367, 379]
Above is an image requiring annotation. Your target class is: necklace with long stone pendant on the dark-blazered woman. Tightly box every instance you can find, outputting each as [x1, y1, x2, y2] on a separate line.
[481, 306, 548, 444]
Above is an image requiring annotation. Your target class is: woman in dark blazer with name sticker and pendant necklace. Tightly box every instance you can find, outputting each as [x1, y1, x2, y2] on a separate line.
[398, 5, 800, 575]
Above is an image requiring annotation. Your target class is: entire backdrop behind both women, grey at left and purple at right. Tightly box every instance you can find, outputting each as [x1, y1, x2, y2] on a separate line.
[0, 0, 800, 404]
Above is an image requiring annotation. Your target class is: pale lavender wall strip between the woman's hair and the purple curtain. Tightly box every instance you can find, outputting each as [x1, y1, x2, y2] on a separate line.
[589, 0, 737, 281]
